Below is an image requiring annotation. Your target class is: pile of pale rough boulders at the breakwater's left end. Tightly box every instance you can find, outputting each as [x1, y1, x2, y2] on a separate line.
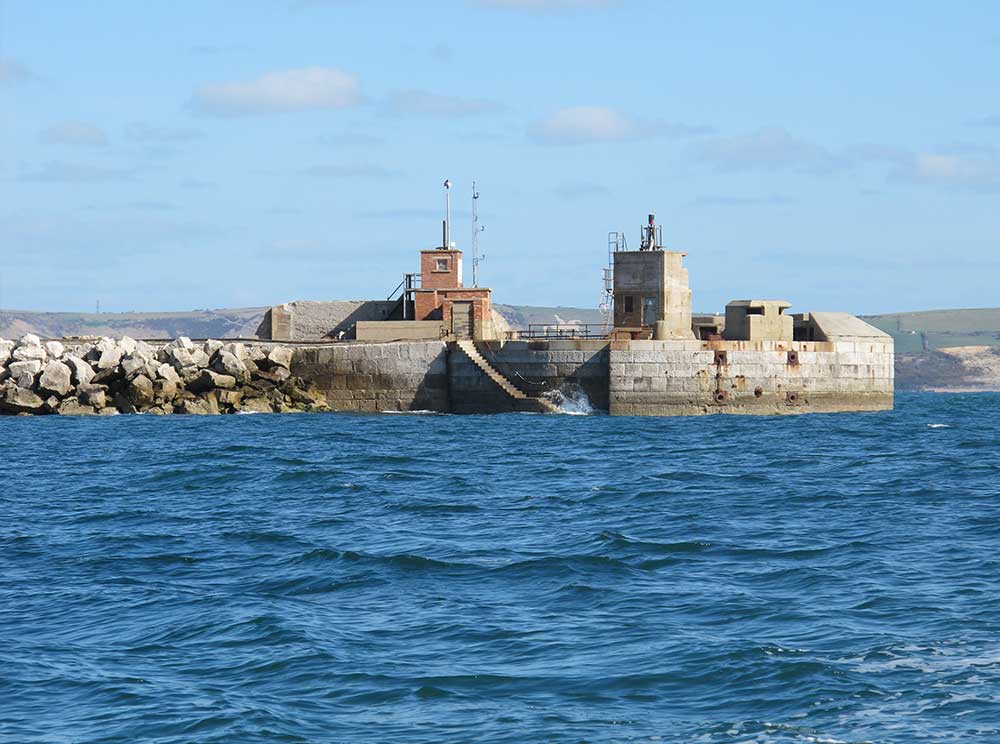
[0, 333, 328, 415]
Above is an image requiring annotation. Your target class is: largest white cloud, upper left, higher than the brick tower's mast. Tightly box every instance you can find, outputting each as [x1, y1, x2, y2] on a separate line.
[193, 67, 362, 116]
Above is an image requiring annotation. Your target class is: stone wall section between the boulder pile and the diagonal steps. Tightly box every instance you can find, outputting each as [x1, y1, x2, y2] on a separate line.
[291, 341, 449, 412]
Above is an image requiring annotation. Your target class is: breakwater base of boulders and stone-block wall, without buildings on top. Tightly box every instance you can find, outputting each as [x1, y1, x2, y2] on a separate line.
[0, 335, 893, 416]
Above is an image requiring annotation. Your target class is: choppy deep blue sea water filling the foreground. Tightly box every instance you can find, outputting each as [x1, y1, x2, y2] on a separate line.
[0, 394, 1000, 744]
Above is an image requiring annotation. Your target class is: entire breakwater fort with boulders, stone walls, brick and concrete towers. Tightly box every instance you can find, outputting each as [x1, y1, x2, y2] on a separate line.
[0, 215, 893, 416]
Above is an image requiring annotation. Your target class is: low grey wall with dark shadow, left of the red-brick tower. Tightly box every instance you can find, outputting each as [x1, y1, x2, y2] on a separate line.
[256, 300, 399, 341]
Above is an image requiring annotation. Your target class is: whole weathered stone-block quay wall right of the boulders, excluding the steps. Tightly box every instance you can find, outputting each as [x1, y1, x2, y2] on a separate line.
[292, 338, 893, 416]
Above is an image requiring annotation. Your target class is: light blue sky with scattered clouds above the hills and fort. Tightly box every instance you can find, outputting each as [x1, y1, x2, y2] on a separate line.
[0, 0, 1000, 313]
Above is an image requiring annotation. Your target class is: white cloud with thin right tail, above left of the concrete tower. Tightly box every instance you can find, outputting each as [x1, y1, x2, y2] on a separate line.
[528, 106, 712, 145]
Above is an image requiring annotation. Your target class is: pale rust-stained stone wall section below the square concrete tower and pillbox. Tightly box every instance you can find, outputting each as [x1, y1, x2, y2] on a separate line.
[609, 339, 893, 416]
